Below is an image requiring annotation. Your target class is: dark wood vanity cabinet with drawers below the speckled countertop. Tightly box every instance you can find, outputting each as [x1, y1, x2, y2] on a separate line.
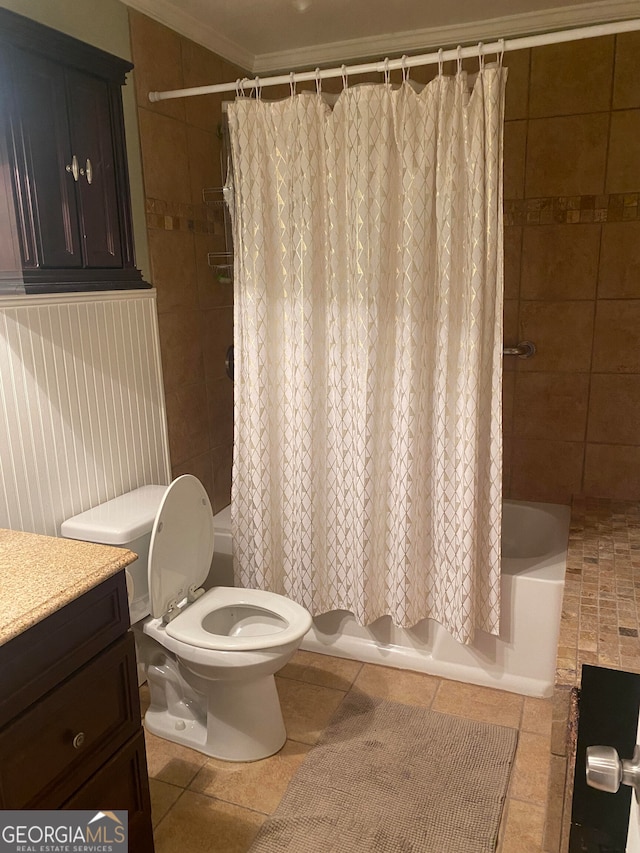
[0, 571, 154, 853]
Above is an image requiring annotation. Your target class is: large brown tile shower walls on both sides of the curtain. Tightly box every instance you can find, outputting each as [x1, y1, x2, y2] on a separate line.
[130, 12, 640, 508]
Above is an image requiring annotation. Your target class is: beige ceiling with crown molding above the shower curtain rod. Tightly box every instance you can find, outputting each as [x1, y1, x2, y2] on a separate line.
[123, 0, 640, 74]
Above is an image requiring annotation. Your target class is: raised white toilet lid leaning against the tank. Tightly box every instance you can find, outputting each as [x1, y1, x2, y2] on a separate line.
[148, 474, 214, 619]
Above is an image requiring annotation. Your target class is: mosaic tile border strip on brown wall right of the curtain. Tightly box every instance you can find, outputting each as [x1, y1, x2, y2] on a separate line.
[504, 193, 640, 225]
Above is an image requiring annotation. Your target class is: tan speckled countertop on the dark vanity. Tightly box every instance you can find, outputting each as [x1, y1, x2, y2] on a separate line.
[0, 528, 136, 645]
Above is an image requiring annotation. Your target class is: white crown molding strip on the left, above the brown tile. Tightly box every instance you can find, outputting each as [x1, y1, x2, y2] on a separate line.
[121, 0, 255, 71]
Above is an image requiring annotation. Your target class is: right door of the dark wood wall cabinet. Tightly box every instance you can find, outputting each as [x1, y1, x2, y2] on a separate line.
[66, 70, 122, 267]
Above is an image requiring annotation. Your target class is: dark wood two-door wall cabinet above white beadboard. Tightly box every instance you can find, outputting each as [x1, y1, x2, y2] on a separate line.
[0, 9, 149, 293]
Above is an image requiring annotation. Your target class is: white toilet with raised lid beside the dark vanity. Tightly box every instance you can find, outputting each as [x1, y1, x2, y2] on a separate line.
[60, 474, 311, 761]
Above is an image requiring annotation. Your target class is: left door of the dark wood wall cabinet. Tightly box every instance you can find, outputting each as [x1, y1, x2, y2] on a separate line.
[10, 50, 83, 269]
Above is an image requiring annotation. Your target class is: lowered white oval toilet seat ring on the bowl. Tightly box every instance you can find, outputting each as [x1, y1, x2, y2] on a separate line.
[165, 586, 311, 651]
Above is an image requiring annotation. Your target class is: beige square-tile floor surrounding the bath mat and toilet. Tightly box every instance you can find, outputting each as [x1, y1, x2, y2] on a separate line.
[141, 651, 552, 853]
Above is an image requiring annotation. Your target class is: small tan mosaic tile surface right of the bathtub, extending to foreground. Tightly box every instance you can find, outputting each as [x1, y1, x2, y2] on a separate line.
[544, 496, 640, 852]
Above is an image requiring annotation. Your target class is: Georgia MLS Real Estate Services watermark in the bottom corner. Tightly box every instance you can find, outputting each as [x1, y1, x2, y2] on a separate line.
[0, 811, 129, 853]
